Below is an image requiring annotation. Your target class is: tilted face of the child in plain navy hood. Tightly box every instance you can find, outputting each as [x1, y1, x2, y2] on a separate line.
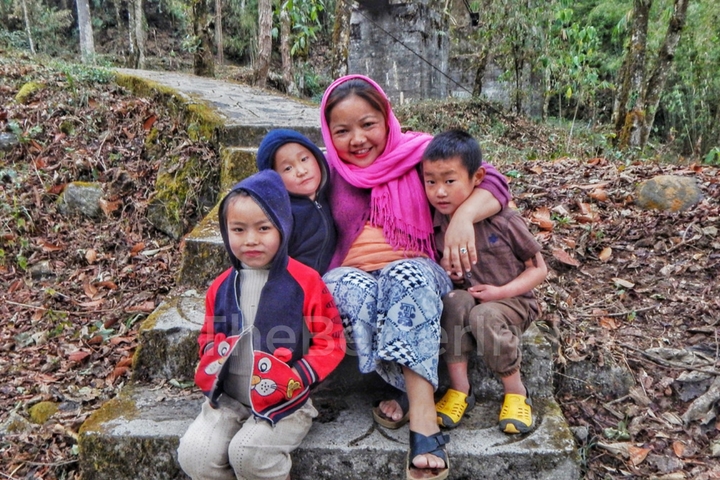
[273, 143, 322, 200]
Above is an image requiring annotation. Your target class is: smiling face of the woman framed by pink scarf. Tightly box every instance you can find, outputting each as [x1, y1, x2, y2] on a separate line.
[328, 95, 387, 168]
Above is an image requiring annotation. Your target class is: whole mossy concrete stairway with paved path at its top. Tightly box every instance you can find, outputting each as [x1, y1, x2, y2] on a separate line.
[79, 70, 580, 480]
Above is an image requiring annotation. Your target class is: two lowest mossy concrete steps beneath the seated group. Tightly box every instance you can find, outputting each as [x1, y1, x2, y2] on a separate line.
[80, 290, 580, 480]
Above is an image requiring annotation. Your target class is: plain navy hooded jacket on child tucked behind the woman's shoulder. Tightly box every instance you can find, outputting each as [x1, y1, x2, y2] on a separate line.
[257, 129, 337, 275]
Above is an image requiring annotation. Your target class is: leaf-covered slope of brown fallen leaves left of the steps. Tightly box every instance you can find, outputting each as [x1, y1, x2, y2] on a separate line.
[0, 58, 213, 480]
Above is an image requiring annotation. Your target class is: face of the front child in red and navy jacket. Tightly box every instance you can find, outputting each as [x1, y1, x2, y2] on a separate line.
[227, 196, 280, 268]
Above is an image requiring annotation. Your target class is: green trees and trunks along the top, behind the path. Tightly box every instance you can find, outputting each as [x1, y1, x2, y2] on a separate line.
[0, 0, 720, 163]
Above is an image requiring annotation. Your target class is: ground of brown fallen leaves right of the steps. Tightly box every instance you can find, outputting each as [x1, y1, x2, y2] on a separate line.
[509, 158, 720, 480]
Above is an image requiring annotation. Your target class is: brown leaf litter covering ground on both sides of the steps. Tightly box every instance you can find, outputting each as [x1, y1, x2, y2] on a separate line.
[0, 57, 720, 479]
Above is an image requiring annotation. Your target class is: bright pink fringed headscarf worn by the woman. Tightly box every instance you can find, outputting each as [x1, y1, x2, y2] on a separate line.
[320, 75, 434, 258]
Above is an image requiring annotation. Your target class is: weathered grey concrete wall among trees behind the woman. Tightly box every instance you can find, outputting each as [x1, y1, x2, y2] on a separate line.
[348, 0, 542, 114]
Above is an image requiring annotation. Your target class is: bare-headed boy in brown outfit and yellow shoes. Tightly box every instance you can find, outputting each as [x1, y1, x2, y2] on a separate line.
[423, 130, 547, 433]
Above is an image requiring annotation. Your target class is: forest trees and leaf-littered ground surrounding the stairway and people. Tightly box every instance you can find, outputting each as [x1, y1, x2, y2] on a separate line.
[0, 0, 720, 480]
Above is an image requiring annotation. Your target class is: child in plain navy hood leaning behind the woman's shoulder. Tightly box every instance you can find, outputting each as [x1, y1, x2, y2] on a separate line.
[257, 129, 337, 275]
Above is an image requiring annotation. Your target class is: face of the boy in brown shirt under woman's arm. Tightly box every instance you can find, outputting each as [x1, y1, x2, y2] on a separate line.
[423, 157, 485, 215]
